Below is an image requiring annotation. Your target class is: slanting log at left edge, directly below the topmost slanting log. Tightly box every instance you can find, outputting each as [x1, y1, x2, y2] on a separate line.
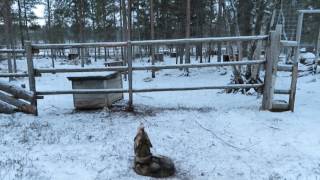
[0, 92, 36, 114]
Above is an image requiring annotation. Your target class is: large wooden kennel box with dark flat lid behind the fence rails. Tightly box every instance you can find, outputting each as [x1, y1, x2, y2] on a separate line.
[68, 72, 123, 110]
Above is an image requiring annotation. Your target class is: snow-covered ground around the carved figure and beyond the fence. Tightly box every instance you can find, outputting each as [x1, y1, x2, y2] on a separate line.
[0, 55, 320, 180]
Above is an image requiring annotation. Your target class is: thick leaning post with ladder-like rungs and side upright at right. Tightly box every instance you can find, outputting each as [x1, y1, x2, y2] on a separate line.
[262, 25, 299, 111]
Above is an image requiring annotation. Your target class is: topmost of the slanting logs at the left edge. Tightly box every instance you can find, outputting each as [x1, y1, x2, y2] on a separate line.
[0, 81, 34, 102]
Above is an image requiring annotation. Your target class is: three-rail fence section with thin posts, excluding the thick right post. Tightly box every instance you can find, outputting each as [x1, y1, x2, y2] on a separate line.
[30, 35, 269, 112]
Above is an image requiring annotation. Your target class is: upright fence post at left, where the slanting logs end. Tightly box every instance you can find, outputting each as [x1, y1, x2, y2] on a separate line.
[25, 41, 38, 116]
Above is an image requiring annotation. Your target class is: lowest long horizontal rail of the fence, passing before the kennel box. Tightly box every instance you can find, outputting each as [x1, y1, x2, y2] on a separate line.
[37, 84, 264, 95]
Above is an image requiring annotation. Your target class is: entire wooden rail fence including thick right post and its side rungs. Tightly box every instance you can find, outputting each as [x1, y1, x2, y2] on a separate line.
[0, 24, 297, 114]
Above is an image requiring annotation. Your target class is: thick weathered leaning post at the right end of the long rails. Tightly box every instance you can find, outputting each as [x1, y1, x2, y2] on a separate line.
[262, 25, 282, 110]
